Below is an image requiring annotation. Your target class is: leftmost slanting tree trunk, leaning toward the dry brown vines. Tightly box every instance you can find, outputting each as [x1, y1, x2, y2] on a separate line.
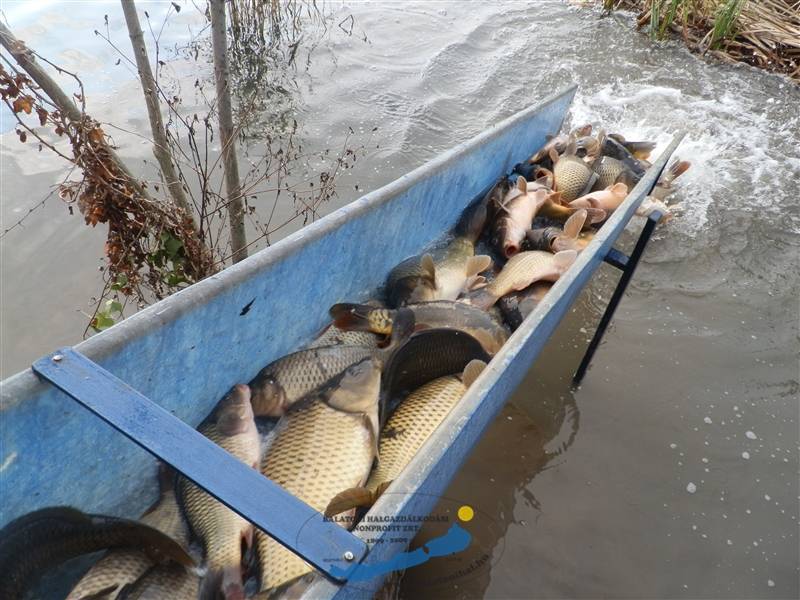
[0, 21, 152, 201]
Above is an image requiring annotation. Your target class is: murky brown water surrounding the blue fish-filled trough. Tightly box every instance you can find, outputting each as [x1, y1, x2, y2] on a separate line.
[0, 1, 800, 598]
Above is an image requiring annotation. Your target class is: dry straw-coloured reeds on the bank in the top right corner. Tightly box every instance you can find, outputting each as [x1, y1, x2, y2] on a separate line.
[598, 0, 800, 83]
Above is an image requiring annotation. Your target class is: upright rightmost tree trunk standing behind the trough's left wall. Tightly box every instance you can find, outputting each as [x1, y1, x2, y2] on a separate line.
[208, 0, 247, 262]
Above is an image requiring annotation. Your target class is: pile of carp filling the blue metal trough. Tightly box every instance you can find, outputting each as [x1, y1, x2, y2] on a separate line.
[0, 126, 689, 600]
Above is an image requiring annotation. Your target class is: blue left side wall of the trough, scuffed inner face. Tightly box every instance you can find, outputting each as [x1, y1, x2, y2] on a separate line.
[0, 87, 575, 526]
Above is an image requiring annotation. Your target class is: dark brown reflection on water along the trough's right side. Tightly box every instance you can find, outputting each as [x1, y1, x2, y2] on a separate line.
[401, 294, 591, 599]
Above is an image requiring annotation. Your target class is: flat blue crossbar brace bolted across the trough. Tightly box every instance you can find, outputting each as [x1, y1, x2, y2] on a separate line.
[33, 348, 367, 581]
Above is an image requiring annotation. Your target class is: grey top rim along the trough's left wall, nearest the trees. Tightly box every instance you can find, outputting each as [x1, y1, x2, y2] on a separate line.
[0, 84, 578, 412]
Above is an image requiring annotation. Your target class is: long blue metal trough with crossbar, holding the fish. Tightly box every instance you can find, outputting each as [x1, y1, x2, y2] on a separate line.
[0, 87, 679, 598]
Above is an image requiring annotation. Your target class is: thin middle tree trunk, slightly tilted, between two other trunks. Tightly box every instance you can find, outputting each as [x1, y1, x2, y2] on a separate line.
[121, 0, 193, 215]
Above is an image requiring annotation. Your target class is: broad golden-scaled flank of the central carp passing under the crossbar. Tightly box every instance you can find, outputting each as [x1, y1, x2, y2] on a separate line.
[256, 396, 377, 590]
